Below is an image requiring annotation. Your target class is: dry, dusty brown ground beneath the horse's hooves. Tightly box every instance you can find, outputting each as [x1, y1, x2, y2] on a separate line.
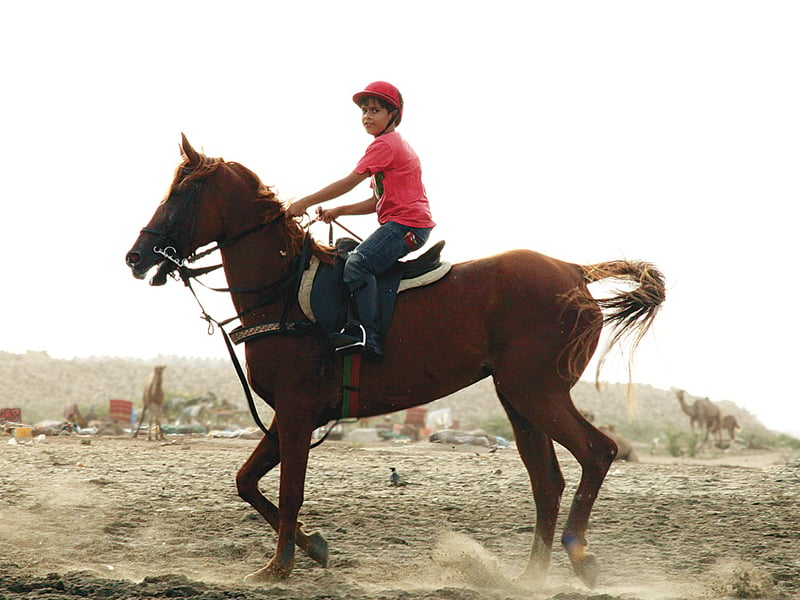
[0, 436, 800, 600]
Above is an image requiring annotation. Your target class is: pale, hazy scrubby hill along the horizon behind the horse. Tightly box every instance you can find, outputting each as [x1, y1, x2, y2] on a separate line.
[0, 352, 780, 442]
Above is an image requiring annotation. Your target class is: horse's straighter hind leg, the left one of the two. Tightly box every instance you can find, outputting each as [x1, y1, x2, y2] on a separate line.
[500, 395, 564, 583]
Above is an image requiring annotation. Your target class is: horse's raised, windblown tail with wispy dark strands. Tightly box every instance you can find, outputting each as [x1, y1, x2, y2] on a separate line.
[570, 260, 666, 386]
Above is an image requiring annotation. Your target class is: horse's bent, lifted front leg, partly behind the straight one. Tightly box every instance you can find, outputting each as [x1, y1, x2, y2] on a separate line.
[236, 422, 328, 567]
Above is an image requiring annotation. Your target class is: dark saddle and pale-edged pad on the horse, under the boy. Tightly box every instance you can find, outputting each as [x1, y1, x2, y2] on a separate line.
[297, 238, 452, 337]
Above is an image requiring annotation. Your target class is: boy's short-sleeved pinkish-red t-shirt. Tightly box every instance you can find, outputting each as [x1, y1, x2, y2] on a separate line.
[355, 131, 435, 227]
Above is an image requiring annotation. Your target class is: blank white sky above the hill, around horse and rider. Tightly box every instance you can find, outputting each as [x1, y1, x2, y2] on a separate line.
[0, 0, 800, 433]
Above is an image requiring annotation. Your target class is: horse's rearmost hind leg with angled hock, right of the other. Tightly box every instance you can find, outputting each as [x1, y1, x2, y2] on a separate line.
[496, 378, 617, 587]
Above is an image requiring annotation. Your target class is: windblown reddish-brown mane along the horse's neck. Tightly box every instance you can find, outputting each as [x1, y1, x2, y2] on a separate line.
[178, 153, 333, 262]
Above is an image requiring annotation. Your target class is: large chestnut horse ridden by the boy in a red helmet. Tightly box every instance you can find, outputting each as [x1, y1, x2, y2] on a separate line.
[126, 136, 665, 586]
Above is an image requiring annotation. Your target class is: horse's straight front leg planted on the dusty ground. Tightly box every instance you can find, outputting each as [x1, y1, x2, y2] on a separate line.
[245, 419, 316, 582]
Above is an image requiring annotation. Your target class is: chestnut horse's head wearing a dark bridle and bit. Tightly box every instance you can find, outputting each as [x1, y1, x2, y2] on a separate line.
[125, 134, 231, 285]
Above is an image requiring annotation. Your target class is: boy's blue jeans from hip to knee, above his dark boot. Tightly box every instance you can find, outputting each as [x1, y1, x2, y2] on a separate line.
[342, 221, 431, 292]
